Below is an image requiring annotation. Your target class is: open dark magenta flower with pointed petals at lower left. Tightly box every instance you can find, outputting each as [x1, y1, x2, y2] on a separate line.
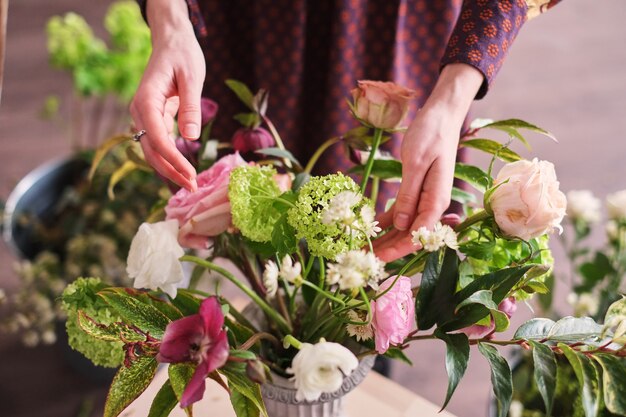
[157, 297, 229, 408]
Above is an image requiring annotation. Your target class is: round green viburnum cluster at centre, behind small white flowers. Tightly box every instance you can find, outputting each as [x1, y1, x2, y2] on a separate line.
[287, 172, 371, 259]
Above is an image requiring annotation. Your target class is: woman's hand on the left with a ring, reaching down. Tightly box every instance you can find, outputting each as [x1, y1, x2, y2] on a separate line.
[130, 0, 206, 190]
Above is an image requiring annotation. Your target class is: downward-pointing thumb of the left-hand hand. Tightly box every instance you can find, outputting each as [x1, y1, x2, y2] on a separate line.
[177, 71, 203, 140]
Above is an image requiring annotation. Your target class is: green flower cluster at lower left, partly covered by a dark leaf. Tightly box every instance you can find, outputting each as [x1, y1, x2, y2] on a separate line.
[62, 278, 124, 368]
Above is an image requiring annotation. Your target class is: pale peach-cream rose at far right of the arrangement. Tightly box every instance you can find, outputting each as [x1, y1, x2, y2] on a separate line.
[490, 158, 567, 240]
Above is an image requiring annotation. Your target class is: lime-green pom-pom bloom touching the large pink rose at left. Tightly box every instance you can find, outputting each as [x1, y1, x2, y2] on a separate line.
[228, 165, 281, 242]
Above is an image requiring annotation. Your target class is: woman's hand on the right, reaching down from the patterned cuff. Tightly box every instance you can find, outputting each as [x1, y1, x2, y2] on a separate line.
[374, 64, 483, 262]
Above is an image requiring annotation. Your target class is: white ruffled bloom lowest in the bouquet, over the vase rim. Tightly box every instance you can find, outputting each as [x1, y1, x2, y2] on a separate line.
[287, 339, 359, 401]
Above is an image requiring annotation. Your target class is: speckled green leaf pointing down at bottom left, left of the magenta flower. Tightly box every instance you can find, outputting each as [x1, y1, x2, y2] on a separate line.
[104, 356, 158, 417]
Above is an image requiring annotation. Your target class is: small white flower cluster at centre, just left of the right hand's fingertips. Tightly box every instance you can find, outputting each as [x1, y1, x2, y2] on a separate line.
[326, 250, 387, 290]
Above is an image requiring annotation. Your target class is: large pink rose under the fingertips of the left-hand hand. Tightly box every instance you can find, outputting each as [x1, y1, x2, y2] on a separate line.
[165, 153, 246, 249]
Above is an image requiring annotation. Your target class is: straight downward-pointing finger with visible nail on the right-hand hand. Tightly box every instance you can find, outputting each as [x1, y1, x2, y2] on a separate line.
[393, 158, 423, 230]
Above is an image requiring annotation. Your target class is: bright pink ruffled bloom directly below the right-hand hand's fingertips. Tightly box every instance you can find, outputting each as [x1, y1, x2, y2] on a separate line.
[372, 276, 415, 354]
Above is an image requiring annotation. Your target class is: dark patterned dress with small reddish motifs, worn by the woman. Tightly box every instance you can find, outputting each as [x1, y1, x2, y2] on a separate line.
[139, 0, 559, 197]
